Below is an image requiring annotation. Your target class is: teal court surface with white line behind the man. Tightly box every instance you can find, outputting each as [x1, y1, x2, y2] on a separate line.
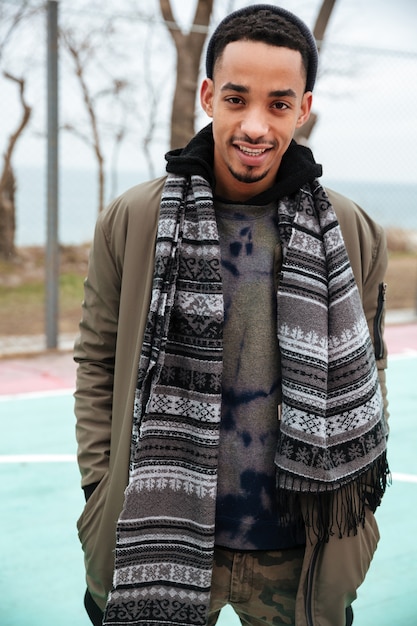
[0, 352, 417, 626]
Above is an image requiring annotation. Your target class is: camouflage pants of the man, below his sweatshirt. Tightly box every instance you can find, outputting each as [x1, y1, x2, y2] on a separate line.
[208, 547, 304, 626]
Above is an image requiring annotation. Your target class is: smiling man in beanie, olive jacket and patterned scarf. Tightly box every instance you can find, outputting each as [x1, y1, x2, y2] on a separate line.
[75, 5, 388, 626]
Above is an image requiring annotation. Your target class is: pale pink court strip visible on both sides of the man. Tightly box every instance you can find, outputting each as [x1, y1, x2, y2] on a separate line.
[0, 323, 417, 395]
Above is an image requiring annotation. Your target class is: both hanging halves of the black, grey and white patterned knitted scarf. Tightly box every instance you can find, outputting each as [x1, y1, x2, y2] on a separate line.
[103, 175, 386, 626]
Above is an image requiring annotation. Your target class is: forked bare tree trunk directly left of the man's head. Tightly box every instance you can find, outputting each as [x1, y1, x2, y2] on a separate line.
[159, 0, 213, 148]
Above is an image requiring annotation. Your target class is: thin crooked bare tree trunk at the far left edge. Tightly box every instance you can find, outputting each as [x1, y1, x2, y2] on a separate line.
[0, 72, 32, 259]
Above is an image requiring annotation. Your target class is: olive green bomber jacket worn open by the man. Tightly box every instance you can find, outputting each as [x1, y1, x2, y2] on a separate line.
[74, 177, 387, 626]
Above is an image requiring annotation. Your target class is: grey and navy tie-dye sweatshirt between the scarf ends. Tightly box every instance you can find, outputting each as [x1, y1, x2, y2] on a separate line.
[215, 200, 303, 550]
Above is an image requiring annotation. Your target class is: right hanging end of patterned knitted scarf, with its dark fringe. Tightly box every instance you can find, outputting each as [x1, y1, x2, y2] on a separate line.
[275, 181, 389, 540]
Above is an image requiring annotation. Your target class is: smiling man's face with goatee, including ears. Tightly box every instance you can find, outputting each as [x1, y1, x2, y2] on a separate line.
[201, 40, 312, 201]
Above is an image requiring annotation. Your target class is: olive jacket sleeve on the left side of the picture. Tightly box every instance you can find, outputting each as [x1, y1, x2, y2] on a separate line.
[74, 207, 121, 490]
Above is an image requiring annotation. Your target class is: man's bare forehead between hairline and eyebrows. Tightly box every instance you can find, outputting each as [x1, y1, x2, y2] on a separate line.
[213, 40, 305, 86]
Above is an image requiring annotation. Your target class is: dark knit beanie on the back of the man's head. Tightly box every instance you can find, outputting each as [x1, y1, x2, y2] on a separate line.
[206, 4, 319, 91]
